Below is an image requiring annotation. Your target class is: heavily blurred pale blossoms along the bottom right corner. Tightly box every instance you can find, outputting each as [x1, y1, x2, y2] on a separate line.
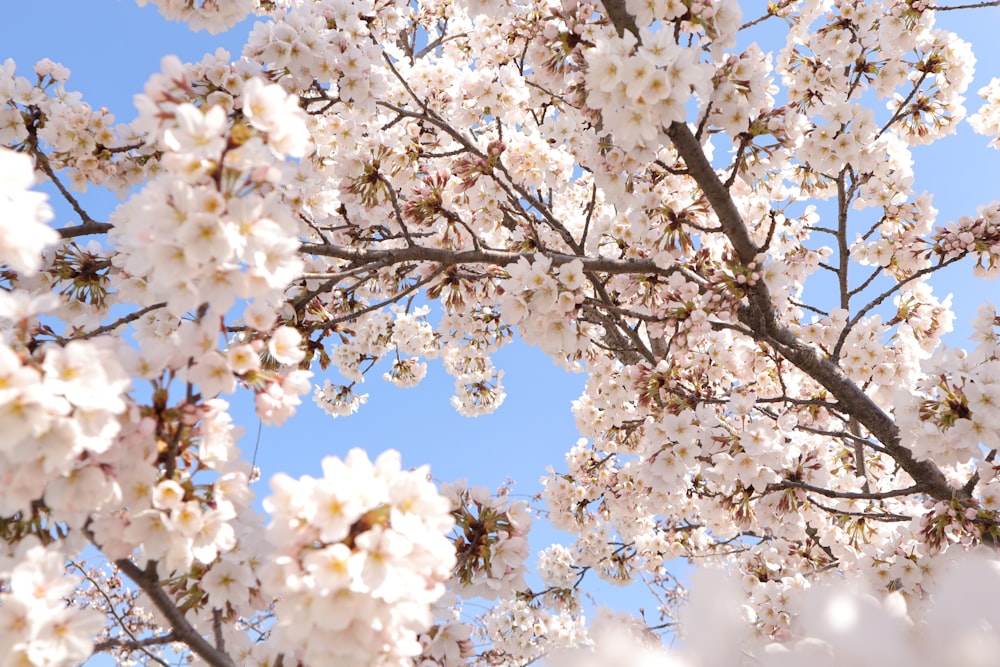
[548, 551, 1000, 667]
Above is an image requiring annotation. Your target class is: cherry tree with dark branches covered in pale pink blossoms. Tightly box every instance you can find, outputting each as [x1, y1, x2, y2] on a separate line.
[0, 0, 1000, 667]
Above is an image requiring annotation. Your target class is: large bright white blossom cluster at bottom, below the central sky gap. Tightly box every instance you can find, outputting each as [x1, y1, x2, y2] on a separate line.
[262, 449, 455, 665]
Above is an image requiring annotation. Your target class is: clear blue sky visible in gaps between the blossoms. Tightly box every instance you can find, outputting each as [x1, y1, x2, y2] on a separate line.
[0, 0, 1000, 640]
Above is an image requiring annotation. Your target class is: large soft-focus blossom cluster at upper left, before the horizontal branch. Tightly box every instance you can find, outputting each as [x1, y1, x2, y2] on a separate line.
[111, 58, 309, 315]
